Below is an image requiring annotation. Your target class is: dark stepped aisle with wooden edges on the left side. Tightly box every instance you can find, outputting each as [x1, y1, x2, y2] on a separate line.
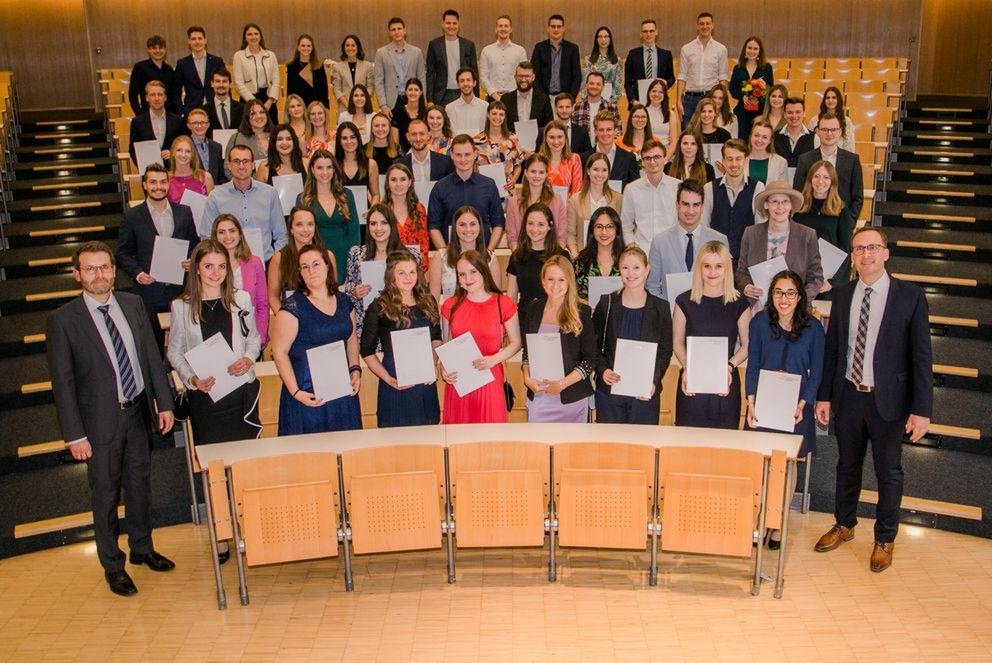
[0, 111, 189, 557]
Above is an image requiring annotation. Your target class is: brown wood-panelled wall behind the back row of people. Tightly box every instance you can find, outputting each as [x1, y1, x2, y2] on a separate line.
[0, 0, 989, 108]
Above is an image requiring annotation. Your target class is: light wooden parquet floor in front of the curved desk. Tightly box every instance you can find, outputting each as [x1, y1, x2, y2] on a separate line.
[0, 513, 992, 663]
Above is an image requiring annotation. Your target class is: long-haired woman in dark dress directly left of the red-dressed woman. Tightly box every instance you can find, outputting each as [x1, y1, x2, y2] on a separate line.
[361, 249, 441, 428]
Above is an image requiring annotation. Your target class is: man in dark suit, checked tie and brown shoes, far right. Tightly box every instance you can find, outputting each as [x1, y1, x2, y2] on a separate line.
[815, 226, 933, 572]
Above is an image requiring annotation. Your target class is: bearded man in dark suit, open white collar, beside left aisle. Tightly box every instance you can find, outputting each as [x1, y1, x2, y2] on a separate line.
[117, 164, 200, 353]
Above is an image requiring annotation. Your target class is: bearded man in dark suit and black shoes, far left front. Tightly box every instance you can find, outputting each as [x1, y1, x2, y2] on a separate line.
[45, 242, 175, 596]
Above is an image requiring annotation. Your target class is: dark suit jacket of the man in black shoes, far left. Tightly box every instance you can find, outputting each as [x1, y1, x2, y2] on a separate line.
[45, 292, 173, 446]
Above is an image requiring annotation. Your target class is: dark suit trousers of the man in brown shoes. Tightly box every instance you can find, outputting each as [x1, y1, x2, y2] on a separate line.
[834, 380, 906, 543]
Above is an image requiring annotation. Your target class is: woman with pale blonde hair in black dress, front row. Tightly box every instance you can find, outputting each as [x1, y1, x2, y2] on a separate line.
[672, 242, 751, 429]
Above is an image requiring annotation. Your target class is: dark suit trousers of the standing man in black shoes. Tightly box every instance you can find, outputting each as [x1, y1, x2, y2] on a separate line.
[87, 393, 152, 571]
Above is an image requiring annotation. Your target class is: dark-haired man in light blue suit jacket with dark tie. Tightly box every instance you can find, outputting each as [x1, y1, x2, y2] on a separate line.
[647, 179, 727, 301]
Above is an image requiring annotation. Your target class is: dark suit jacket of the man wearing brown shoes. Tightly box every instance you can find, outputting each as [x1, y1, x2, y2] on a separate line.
[816, 275, 933, 421]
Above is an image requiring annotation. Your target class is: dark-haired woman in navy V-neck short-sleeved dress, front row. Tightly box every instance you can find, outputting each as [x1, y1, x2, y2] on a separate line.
[272, 245, 362, 435]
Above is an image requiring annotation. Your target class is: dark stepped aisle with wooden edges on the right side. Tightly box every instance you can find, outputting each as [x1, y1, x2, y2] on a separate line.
[813, 97, 992, 537]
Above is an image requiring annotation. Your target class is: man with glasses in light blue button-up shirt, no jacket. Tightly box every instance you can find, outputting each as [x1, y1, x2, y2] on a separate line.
[199, 145, 289, 263]
